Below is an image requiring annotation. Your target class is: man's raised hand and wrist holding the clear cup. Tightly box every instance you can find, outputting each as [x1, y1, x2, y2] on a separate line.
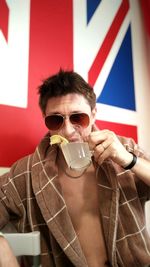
[86, 130, 150, 186]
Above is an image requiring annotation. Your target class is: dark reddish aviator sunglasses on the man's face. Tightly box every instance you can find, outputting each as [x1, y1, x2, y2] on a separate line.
[45, 113, 90, 131]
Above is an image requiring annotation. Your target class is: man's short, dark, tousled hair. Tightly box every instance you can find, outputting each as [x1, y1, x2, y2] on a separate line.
[38, 69, 96, 114]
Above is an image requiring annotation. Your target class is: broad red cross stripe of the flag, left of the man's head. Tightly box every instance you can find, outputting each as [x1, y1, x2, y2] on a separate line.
[0, 0, 73, 167]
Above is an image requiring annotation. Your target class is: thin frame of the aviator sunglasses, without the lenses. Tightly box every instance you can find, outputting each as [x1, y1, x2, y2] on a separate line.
[45, 112, 90, 131]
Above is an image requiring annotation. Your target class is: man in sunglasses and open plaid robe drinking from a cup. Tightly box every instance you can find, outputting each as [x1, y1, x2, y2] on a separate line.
[0, 70, 150, 267]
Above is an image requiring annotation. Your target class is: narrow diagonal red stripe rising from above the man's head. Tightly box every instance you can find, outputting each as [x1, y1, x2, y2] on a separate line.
[88, 0, 129, 86]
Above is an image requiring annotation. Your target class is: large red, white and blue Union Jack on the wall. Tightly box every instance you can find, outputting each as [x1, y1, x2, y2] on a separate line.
[0, 0, 146, 167]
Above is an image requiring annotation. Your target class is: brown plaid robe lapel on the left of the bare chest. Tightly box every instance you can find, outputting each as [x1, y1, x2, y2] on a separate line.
[32, 136, 87, 267]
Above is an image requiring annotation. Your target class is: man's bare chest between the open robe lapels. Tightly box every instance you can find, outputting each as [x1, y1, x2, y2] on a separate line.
[59, 170, 107, 267]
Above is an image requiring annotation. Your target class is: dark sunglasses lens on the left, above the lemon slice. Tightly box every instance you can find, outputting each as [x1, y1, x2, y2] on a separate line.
[45, 115, 64, 131]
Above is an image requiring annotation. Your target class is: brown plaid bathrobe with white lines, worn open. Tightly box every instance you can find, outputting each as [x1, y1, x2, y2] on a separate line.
[0, 134, 150, 267]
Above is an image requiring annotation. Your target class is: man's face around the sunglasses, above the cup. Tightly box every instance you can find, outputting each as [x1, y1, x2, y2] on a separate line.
[45, 93, 96, 142]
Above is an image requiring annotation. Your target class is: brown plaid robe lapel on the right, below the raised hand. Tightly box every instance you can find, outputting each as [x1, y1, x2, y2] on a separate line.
[98, 160, 119, 267]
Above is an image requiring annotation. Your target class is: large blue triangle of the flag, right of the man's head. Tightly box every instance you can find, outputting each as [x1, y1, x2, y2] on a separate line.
[97, 26, 136, 111]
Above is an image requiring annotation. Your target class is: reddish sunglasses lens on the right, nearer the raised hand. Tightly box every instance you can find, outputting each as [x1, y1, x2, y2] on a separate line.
[70, 113, 89, 128]
